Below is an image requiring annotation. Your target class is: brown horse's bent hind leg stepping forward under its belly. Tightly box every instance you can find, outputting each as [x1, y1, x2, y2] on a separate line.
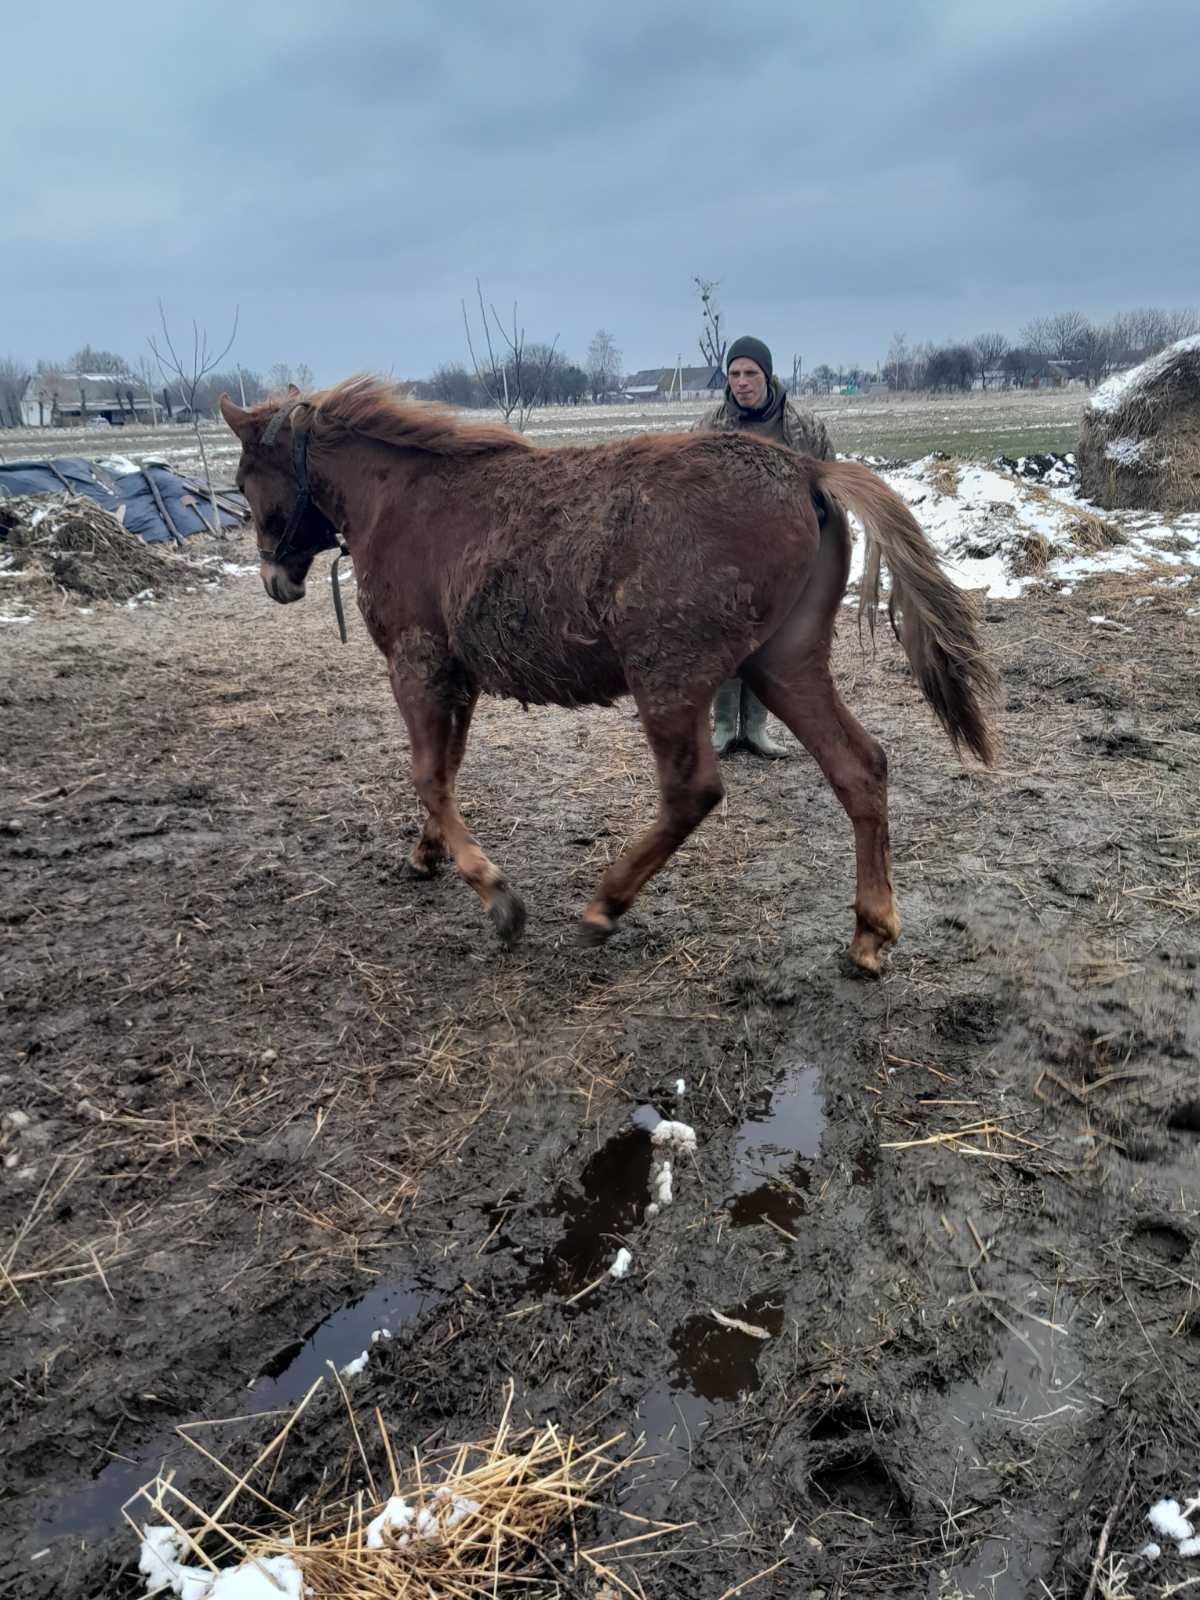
[582, 696, 725, 944]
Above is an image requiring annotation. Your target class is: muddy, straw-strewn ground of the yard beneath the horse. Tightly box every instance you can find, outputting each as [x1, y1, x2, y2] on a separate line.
[0, 544, 1200, 1600]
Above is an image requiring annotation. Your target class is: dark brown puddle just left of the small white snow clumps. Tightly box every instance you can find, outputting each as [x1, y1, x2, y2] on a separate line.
[525, 1128, 651, 1294]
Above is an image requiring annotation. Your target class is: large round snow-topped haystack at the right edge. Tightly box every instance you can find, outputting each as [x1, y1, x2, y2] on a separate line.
[1078, 336, 1200, 515]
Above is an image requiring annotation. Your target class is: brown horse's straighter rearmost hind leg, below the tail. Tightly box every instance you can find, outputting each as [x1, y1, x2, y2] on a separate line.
[742, 652, 899, 974]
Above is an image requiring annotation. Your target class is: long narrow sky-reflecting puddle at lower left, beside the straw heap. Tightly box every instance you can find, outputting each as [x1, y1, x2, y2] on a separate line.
[38, 1283, 437, 1541]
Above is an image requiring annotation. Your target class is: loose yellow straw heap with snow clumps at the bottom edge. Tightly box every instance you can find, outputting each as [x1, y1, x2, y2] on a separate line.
[125, 1384, 690, 1600]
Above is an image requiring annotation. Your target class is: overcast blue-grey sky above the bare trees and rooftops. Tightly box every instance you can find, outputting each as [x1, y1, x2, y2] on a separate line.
[0, 0, 1200, 381]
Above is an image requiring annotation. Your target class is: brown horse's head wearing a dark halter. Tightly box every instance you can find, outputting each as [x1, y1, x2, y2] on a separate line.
[221, 384, 339, 605]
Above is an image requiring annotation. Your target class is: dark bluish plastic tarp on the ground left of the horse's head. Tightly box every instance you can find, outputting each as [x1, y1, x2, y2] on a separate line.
[0, 456, 246, 544]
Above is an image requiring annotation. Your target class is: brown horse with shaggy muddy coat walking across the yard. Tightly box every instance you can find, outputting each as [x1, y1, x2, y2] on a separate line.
[221, 378, 995, 973]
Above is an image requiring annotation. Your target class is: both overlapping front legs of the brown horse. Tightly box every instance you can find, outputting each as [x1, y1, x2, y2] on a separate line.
[389, 662, 525, 944]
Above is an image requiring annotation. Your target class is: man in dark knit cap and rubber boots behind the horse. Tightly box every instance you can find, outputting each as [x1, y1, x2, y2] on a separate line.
[696, 338, 834, 760]
